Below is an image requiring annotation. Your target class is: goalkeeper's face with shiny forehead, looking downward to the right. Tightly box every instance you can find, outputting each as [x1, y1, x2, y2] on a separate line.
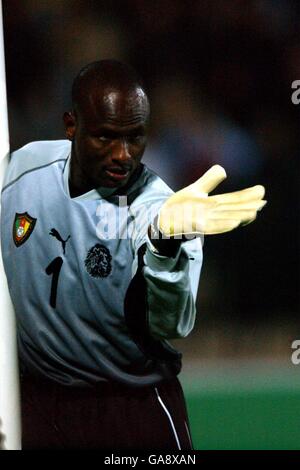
[65, 88, 149, 189]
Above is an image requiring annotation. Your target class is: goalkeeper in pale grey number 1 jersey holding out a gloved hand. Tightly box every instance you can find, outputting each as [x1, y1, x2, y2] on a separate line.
[1, 60, 265, 450]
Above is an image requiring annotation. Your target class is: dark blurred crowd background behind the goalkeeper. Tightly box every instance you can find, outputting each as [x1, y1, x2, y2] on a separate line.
[3, 0, 300, 326]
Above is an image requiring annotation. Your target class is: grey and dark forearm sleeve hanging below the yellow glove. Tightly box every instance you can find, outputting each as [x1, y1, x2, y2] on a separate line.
[143, 238, 202, 339]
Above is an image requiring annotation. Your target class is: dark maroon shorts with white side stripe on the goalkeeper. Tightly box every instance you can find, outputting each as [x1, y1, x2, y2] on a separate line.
[21, 378, 192, 450]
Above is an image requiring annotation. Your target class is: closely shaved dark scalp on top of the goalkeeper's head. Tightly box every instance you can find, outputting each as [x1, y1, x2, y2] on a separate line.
[72, 60, 148, 113]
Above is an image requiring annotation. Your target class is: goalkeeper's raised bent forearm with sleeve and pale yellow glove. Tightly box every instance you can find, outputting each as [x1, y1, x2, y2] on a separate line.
[130, 165, 266, 339]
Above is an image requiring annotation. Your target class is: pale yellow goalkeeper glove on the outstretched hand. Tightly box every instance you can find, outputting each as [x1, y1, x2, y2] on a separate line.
[158, 165, 267, 237]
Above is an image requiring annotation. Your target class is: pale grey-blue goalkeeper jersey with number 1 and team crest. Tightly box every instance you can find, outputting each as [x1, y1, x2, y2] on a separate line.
[1, 140, 202, 386]
